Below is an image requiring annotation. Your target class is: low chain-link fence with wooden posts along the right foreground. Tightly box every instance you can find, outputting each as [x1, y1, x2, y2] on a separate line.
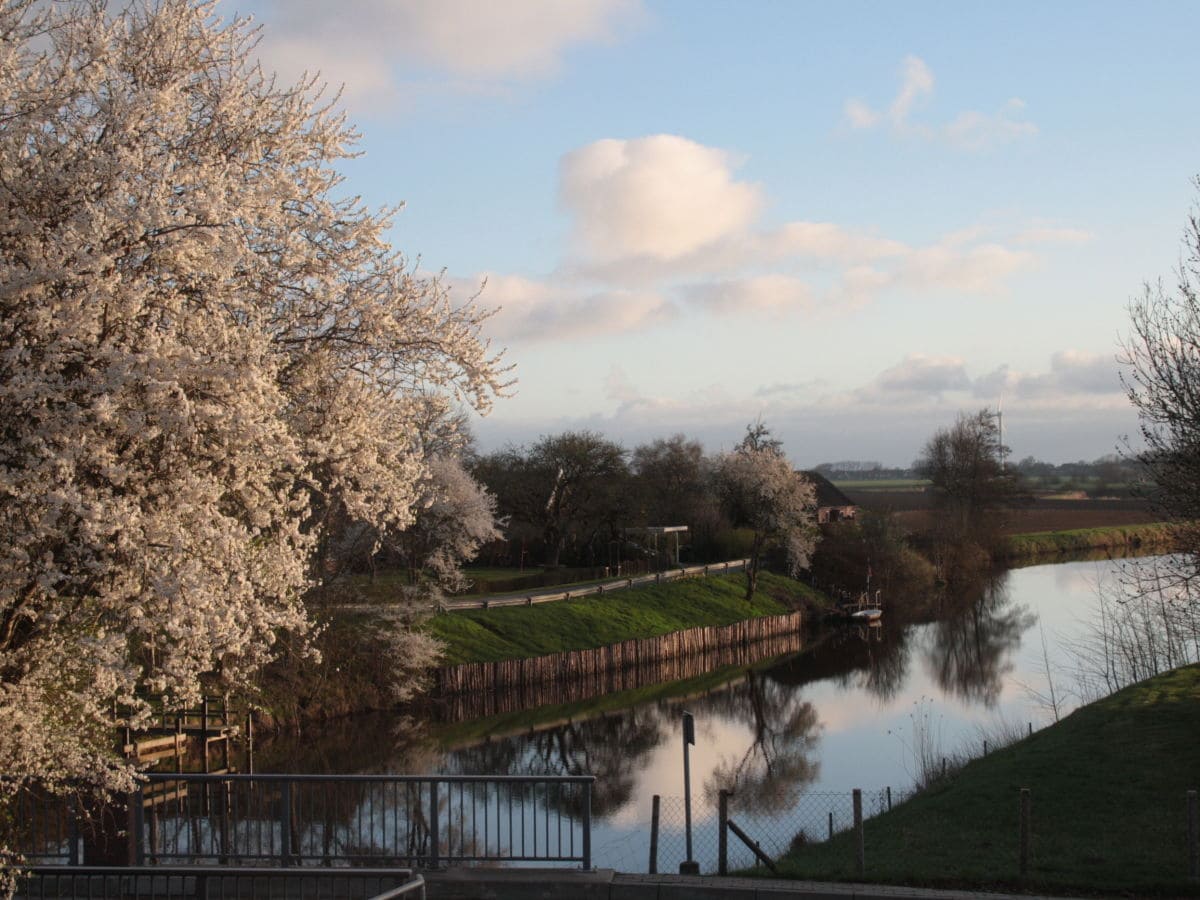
[619, 788, 1200, 895]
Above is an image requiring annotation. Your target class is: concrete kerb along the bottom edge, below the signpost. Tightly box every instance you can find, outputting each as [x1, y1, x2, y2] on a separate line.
[422, 868, 1080, 900]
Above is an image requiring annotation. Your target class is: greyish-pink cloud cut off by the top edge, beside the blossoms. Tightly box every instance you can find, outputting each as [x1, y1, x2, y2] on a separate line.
[248, 0, 643, 106]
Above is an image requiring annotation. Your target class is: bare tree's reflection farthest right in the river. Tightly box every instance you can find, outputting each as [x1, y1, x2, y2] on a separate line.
[926, 572, 1037, 707]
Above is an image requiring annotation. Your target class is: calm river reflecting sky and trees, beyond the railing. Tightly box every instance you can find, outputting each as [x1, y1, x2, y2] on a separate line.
[257, 560, 1147, 871]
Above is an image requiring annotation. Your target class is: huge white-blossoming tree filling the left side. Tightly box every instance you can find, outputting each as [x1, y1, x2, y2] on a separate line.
[0, 0, 505, 811]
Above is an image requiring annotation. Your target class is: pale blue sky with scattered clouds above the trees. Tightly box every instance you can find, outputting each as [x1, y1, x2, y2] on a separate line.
[225, 0, 1200, 466]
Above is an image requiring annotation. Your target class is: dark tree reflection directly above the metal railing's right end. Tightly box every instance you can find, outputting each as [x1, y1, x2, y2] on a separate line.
[446, 707, 665, 816]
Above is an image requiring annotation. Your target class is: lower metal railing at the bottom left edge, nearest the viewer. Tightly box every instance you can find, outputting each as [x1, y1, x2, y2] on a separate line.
[14, 866, 425, 900]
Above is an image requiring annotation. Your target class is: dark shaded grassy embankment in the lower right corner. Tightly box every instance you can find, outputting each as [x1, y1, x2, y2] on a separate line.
[779, 666, 1200, 896]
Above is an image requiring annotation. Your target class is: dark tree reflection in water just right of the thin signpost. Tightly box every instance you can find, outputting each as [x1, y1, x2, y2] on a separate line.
[704, 670, 821, 812]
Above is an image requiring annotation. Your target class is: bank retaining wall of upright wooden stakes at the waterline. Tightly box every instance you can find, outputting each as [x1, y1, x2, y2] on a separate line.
[433, 612, 803, 721]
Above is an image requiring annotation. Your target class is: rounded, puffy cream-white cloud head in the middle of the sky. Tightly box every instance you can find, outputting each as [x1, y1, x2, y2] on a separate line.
[559, 134, 762, 260]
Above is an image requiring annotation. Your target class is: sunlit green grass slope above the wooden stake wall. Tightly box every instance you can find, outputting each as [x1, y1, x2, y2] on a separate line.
[425, 572, 828, 665]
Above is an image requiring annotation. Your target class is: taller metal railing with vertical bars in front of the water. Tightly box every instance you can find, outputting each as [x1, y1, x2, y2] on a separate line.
[16, 773, 595, 869]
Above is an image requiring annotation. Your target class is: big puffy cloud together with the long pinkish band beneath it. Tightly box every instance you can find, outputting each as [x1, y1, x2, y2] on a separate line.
[460, 133, 1085, 340]
